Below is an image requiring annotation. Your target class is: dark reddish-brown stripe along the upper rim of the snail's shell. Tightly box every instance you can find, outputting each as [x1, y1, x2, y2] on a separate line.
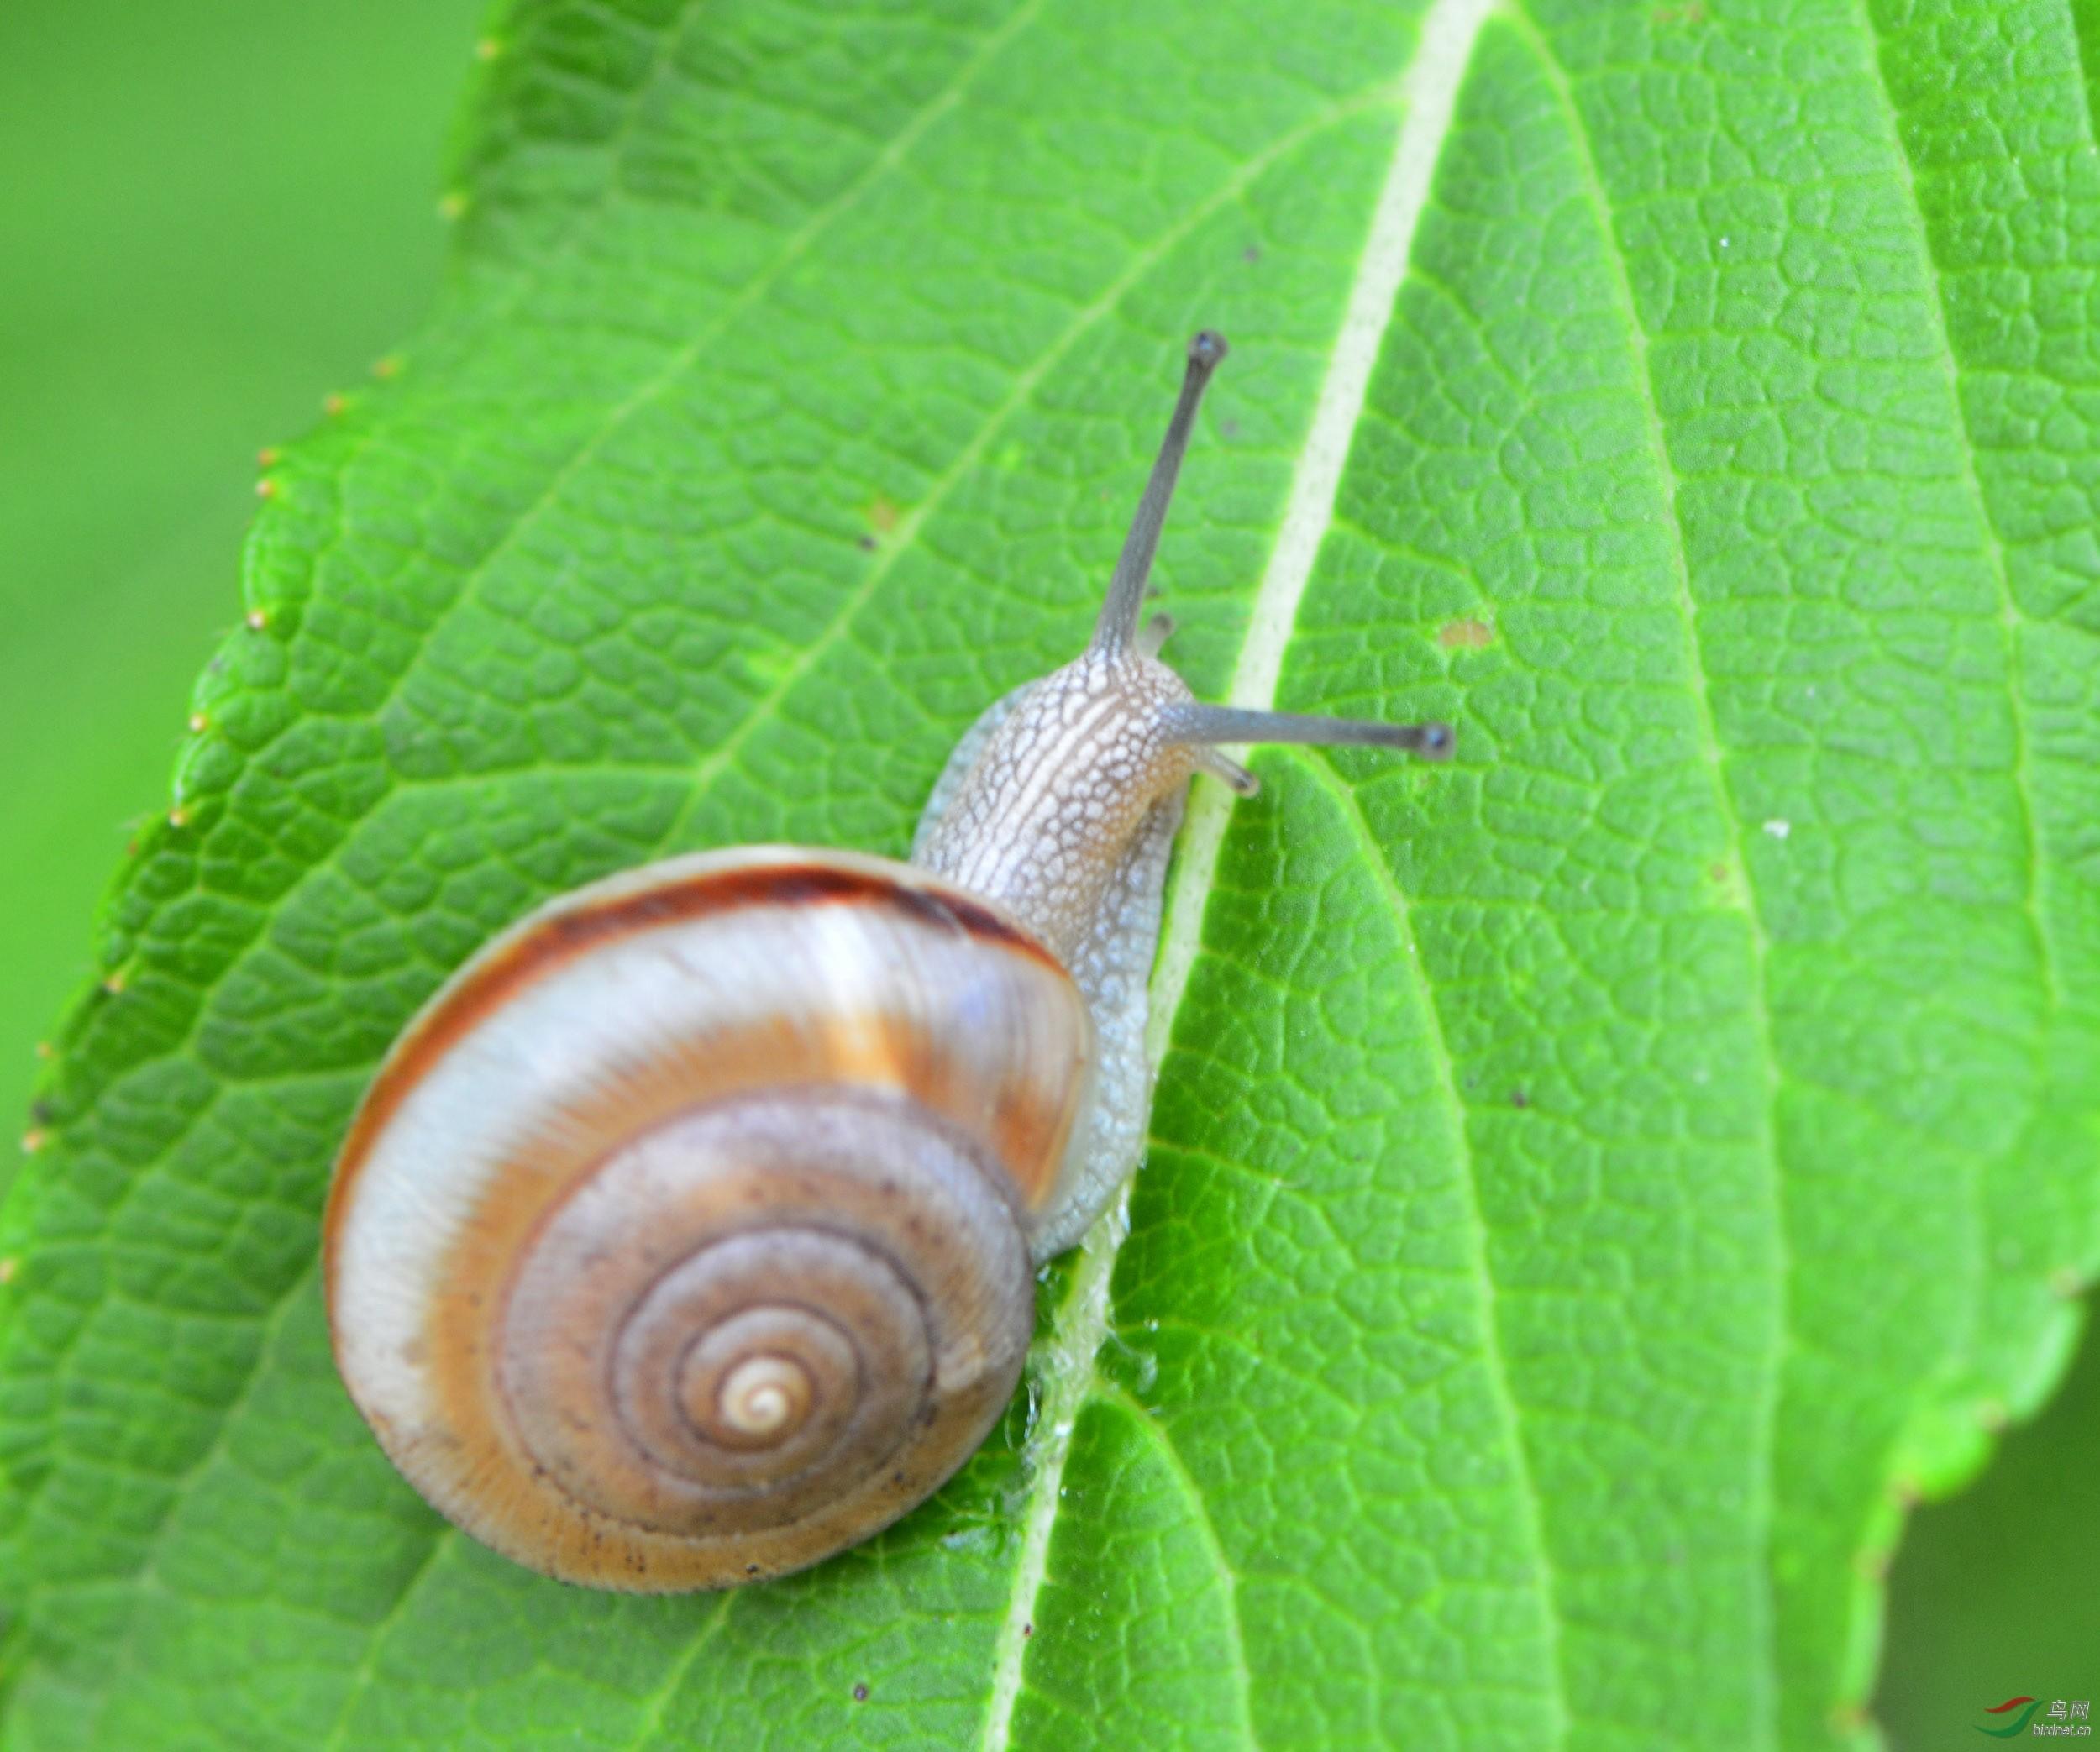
[322, 855, 1063, 1303]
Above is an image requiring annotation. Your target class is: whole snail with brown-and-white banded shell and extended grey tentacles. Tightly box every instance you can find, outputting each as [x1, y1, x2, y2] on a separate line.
[323, 332, 1452, 1592]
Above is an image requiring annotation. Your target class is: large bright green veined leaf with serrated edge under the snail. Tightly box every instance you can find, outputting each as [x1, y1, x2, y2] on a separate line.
[0, 0, 2100, 1748]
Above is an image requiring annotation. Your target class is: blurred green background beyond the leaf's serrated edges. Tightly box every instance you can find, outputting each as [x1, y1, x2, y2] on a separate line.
[0, 0, 2100, 1752]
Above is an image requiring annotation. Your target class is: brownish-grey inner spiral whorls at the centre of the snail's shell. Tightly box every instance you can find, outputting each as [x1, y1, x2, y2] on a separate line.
[483, 1090, 1032, 1573]
